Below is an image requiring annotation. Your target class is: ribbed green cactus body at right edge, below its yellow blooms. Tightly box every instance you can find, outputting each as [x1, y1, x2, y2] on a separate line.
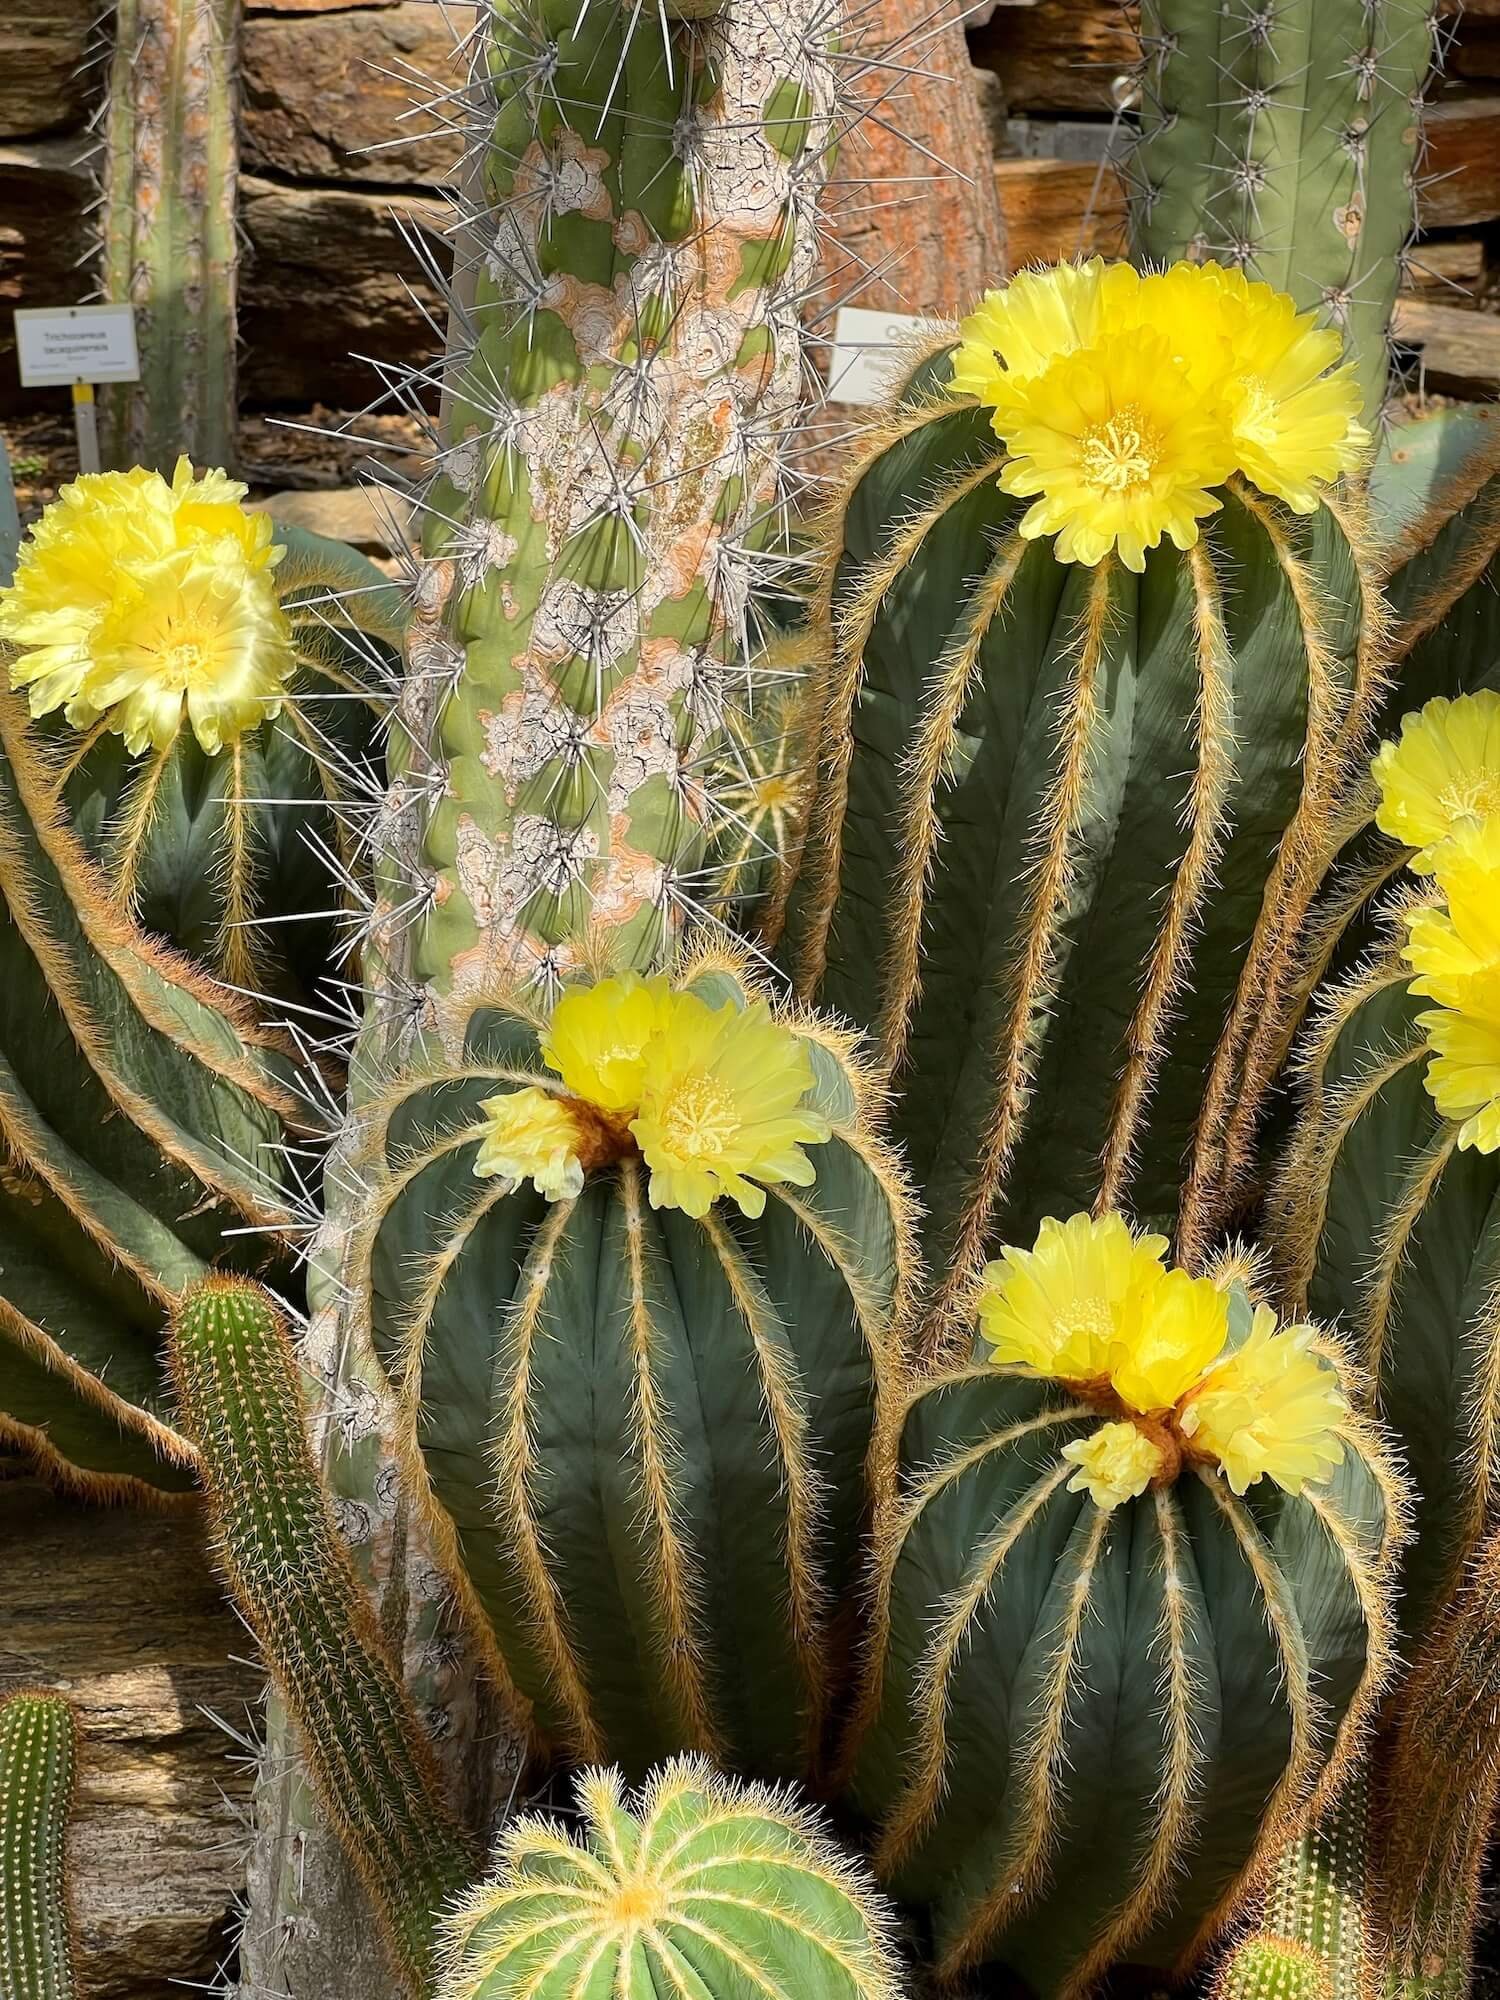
[1270, 928, 1500, 1632]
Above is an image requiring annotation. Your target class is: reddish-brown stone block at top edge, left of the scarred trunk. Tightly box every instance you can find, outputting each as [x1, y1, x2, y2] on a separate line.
[240, 0, 472, 186]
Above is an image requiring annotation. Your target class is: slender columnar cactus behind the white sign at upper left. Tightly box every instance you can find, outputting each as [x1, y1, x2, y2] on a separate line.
[100, 0, 240, 474]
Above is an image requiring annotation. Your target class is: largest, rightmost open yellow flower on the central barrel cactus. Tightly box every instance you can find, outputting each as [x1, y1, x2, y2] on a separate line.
[630, 994, 832, 1216]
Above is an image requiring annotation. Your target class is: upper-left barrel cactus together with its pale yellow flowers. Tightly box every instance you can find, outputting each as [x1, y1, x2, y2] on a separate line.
[0, 470, 406, 994]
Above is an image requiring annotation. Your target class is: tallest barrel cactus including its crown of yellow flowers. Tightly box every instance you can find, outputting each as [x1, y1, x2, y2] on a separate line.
[782, 260, 1382, 1320]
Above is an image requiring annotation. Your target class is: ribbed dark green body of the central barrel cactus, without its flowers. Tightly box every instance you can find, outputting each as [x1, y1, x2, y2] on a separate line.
[356, 966, 908, 1776]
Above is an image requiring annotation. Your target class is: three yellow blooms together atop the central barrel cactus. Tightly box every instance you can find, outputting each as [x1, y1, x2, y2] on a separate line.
[474, 972, 832, 1216]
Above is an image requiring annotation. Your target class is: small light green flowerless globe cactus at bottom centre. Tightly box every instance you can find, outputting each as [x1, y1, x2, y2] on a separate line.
[440, 1758, 902, 2000]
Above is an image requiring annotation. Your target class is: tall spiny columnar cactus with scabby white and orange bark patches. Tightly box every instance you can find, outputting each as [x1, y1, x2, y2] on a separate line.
[242, 0, 840, 2000]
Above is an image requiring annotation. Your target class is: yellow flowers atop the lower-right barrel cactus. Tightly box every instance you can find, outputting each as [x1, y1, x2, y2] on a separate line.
[978, 1216, 1348, 1508]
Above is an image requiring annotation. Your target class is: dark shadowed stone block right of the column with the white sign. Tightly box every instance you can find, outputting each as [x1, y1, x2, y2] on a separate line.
[240, 178, 450, 410]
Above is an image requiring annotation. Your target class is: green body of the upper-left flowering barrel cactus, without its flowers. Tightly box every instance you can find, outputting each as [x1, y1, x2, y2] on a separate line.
[42, 526, 406, 994]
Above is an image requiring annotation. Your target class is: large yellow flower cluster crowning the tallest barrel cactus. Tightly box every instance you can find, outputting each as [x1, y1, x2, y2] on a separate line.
[950, 258, 1370, 570]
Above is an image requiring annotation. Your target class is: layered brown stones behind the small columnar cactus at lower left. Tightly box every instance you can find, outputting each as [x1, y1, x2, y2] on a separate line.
[0, 1478, 262, 2000]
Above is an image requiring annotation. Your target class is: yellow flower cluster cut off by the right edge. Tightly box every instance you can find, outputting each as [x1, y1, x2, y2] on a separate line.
[1374, 690, 1500, 1152]
